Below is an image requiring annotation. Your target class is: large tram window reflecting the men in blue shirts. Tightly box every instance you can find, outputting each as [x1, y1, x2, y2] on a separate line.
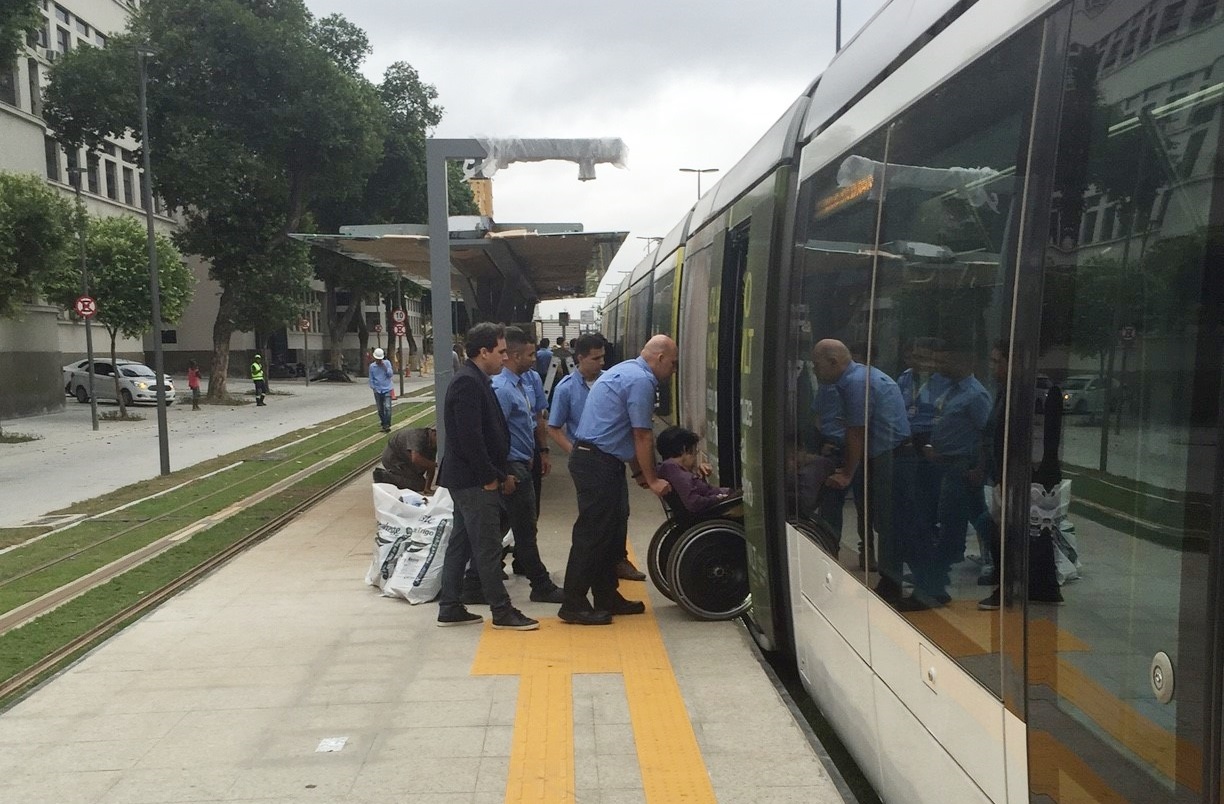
[789, 15, 1040, 691]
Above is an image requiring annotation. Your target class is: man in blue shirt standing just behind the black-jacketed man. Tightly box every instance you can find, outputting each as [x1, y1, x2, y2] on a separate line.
[493, 327, 563, 603]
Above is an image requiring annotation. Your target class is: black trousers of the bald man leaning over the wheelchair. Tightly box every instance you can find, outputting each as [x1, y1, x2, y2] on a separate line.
[564, 445, 629, 611]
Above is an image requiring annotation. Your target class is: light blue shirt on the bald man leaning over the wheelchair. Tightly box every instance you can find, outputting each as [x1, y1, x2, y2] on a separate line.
[574, 356, 659, 460]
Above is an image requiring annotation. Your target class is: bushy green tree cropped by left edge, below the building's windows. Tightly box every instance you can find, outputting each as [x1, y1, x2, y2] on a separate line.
[0, 173, 73, 316]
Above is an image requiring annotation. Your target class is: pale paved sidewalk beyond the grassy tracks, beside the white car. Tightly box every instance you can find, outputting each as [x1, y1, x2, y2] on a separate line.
[0, 376, 433, 527]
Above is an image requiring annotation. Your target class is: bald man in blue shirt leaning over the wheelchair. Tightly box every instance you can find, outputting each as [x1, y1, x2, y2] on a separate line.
[557, 335, 678, 625]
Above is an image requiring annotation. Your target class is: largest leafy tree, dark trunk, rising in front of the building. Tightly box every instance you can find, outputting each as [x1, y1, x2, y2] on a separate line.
[44, 0, 384, 398]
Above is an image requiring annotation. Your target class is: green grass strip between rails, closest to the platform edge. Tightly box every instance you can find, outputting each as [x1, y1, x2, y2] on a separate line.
[0, 442, 382, 709]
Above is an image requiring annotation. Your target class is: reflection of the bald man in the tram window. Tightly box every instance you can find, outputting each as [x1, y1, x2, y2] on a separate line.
[812, 338, 913, 607]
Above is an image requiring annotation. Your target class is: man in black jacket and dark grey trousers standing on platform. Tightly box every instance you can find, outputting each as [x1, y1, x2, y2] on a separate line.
[438, 323, 540, 631]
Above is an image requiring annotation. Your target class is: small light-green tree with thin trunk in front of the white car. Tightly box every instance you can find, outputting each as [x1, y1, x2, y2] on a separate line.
[47, 215, 188, 416]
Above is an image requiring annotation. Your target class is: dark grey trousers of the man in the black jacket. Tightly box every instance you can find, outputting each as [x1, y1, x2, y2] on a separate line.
[438, 486, 510, 612]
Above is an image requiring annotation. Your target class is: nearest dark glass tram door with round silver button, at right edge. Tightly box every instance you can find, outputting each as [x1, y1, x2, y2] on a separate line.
[1024, 0, 1224, 803]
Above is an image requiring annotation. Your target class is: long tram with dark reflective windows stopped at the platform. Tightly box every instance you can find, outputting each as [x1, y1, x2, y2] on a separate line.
[603, 0, 1224, 803]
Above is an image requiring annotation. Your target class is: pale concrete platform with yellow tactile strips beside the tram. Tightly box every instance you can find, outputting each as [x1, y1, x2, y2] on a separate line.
[0, 455, 842, 804]
